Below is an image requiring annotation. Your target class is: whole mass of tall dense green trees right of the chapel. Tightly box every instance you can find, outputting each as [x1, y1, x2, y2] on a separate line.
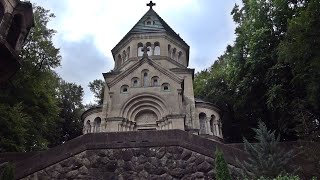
[194, 0, 320, 142]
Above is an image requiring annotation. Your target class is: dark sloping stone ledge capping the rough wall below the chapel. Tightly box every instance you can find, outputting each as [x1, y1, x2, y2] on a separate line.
[15, 130, 245, 179]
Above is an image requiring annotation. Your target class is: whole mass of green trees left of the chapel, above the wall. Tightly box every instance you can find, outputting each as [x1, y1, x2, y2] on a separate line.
[0, 5, 83, 152]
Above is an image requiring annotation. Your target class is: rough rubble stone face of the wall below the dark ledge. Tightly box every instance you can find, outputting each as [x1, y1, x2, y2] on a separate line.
[23, 146, 238, 180]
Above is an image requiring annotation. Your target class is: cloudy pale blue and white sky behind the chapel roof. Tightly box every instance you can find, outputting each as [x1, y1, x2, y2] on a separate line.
[31, 0, 239, 103]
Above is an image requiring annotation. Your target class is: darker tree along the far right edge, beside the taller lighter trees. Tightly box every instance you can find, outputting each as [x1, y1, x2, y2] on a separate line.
[278, 0, 320, 141]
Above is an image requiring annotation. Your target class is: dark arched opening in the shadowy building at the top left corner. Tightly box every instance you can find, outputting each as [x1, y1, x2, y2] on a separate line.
[6, 14, 22, 49]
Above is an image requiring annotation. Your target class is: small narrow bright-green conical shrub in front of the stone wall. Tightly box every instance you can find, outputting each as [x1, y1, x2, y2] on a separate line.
[215, 148, 231, 180]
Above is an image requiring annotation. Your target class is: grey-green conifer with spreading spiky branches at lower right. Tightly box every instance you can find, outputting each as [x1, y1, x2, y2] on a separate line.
[239, 121, 293, 178]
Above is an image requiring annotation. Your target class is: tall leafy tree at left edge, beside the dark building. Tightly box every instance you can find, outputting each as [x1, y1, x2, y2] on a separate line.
[0, 6, 61, 151]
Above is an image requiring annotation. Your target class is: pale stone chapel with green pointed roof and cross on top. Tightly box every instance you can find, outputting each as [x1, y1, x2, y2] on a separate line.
[81, 1, 223, 139]
